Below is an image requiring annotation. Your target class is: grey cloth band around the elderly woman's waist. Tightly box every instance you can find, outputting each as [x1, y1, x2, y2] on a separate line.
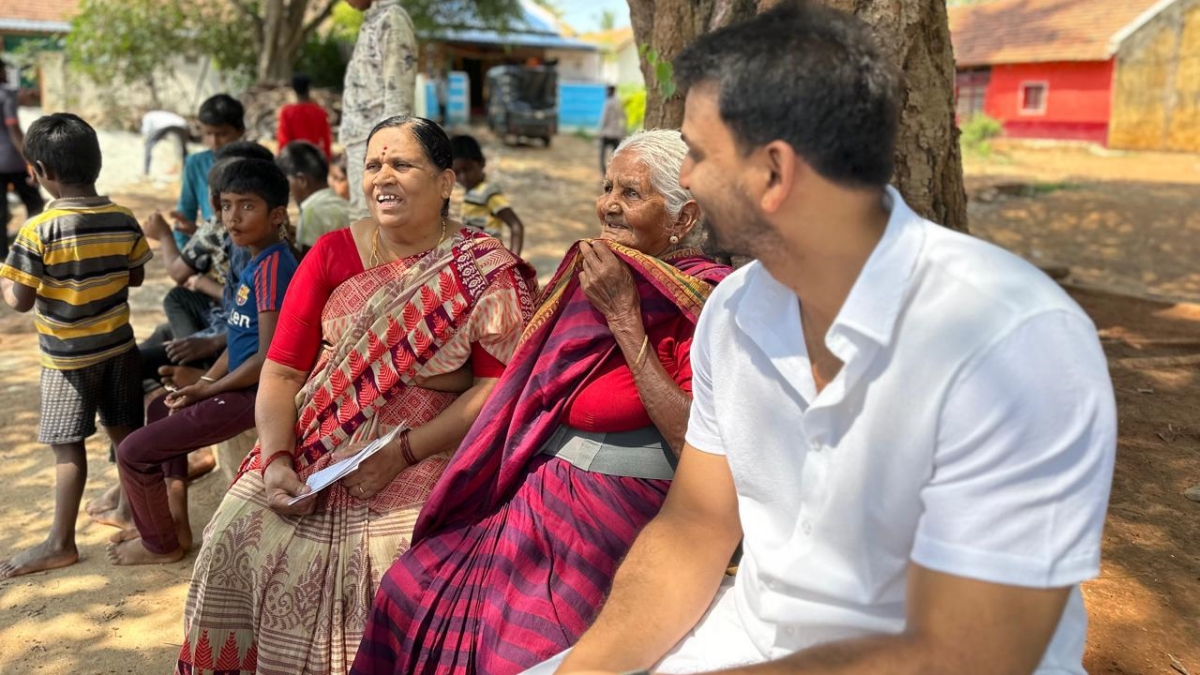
[541, 424, 679, 480]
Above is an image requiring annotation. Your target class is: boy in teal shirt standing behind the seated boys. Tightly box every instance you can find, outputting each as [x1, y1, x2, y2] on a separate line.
[170, 94, 246, 249]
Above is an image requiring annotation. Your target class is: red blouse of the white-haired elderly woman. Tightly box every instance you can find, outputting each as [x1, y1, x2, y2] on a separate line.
[563, 315, 696, 432]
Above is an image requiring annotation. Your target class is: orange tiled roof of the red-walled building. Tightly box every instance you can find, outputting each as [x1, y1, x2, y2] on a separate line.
[949, 0, 1175, 67]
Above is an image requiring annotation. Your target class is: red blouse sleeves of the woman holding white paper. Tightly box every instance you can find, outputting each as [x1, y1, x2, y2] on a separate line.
[266, 227, 504, 377]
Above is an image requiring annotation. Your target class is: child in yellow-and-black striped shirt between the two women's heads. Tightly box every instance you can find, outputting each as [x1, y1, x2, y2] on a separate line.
[450, 136, 524, 256]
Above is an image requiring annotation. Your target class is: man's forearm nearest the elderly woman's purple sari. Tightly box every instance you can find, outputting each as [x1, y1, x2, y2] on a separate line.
[558, 512, 739, 674]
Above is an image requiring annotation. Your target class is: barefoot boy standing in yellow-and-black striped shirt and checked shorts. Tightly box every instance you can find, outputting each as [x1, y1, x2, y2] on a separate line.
[0, 113, 150, 579]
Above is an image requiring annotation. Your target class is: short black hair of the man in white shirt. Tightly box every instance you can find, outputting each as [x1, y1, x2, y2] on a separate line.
[674, 0, 900, 187]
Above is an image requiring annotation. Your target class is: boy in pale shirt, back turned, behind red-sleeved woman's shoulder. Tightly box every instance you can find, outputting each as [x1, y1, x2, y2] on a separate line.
[275, 141, 350, 255]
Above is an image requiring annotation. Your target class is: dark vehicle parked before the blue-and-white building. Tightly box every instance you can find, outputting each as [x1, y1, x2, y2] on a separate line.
[487, 65, 558, 147]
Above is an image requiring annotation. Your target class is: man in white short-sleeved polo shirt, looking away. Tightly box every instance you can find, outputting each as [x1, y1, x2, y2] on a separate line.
[539, 2, 1116, 675]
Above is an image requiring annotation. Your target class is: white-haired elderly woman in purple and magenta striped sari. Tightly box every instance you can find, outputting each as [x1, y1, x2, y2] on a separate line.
[352, 131, 730, 675]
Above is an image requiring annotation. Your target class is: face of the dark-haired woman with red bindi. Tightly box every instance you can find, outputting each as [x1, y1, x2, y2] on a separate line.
[362, 126, 454, 227]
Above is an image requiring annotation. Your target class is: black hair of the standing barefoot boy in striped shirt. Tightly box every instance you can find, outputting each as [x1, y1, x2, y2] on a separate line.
[25, 113, 101, 185]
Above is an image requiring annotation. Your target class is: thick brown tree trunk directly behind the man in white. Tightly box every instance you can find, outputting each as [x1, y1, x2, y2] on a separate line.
[629, 0, 967, 232]
